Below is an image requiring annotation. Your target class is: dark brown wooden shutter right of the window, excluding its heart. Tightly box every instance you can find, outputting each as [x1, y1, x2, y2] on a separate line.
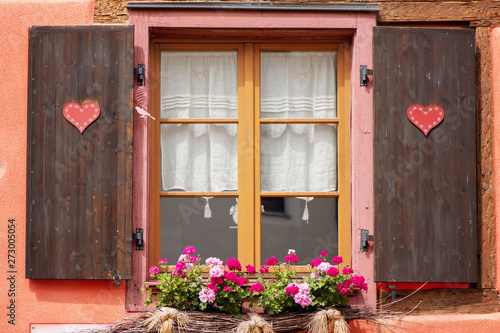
[373, 27, 477, 283]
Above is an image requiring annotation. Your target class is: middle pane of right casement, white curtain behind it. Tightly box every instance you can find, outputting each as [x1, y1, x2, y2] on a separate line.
[261, 124, 337, 192]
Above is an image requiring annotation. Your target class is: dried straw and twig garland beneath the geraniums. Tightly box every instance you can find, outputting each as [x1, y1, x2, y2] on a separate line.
[81, 307, 397, 333]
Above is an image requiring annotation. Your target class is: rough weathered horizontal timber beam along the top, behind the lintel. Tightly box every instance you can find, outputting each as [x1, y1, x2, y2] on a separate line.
[94, 0, 500, 27]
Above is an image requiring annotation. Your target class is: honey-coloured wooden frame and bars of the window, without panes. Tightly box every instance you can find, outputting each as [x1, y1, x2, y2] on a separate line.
[149, 38, 351, 272]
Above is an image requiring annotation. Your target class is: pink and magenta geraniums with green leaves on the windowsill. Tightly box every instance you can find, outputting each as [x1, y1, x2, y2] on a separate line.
[146, 246, 367, 316]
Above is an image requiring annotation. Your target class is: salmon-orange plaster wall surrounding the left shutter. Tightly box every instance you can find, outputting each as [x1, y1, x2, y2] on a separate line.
[0, 0, 129, 333]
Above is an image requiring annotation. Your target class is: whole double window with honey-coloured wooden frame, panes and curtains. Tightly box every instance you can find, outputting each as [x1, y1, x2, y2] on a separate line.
[150, 41, 350, 266]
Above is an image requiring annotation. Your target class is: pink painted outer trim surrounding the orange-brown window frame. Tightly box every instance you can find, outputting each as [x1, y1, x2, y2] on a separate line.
[126, 9, 377, 311]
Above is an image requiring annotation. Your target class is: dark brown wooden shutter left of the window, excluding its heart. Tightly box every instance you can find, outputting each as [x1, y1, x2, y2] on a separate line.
[26, 26, 134, 279]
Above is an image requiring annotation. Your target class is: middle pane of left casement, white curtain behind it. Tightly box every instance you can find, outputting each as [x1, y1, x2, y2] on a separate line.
[161, 124, 238, 192]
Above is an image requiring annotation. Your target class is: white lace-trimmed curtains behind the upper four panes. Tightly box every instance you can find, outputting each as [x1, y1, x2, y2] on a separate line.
[161, 52, 337, 192]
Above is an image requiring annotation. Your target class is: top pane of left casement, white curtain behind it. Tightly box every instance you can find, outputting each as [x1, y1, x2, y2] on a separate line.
[161, 51, 238, 118]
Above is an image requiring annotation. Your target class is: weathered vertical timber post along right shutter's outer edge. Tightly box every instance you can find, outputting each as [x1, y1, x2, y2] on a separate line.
[476, 27, 497, 288]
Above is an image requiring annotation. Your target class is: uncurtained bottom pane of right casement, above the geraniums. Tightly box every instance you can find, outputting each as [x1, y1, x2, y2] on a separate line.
[261, 198, 338, 265]
